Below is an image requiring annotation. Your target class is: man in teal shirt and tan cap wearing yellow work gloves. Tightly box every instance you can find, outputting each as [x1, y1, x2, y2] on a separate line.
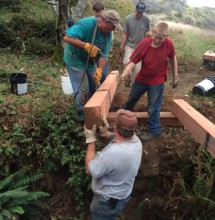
[64, 10, 122, 121]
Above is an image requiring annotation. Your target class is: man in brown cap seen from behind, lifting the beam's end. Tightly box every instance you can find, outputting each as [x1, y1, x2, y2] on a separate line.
[85, 109, 142, 220]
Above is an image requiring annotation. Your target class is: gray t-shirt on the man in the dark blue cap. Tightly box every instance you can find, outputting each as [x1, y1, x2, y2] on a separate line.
[123, 13, 150, 48]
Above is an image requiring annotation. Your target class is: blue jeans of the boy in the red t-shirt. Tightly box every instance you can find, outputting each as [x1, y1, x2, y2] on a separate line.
[124, 80, 164, 135]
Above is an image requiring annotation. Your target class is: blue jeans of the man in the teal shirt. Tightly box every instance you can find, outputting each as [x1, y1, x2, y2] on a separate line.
[66, 65, 96, 121]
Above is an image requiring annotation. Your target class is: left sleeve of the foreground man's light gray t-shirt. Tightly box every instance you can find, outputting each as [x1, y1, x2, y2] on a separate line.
[88, 152, 109, 179]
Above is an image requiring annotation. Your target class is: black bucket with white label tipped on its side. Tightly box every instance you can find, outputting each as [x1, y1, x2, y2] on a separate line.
[192, 76, 215, 96]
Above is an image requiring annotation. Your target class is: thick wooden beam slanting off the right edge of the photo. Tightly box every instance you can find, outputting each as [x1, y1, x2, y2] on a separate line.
[172, 99, 215, 158]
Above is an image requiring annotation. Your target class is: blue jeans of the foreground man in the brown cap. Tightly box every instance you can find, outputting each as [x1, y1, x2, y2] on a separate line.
[90, 194, 131, 220]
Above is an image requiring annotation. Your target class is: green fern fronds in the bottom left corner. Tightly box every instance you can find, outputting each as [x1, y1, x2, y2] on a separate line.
[0, 169, 49, 220]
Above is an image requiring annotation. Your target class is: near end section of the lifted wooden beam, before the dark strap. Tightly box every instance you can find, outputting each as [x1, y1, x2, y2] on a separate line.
[84, 91, 110, 128]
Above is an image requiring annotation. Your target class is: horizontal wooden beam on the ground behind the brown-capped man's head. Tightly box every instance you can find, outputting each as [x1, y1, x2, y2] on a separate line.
[107, 112, 183, 127]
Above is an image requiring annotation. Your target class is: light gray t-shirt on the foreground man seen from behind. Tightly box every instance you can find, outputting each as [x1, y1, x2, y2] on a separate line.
[89, 135, 142, 199]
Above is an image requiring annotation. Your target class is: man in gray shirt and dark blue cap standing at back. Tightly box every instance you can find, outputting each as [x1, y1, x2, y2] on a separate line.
[119, 2, 150, 85]
